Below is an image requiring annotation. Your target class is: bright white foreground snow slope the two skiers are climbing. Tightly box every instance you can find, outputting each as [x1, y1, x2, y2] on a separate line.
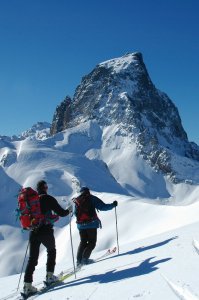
[0, 194, 199, 300]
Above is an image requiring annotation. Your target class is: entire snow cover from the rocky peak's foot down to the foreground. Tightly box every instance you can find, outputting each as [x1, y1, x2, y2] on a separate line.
[0, 122, 199, 300]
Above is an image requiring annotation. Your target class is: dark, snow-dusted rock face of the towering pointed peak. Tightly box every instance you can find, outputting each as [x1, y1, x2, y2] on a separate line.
[51, 52, 199, 181]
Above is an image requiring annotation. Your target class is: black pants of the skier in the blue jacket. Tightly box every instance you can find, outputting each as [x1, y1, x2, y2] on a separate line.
[77, 228, 97, 262]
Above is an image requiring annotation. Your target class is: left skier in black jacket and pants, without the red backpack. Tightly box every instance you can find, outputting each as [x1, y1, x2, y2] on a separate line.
[23, 180, 72, 295]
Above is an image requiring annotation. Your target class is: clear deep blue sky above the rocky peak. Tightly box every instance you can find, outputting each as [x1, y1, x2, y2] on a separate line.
[0, 0, 199, 144]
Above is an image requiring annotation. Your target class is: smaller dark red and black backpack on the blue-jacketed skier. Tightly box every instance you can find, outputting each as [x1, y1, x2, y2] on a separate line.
[73, 194, 98, 224]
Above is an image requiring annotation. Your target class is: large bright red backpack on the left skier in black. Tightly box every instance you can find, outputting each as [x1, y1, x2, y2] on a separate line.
[16, 187, 59, 230]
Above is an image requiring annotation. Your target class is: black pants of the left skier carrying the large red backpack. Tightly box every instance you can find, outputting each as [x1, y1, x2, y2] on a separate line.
[24, 225, 56, 282]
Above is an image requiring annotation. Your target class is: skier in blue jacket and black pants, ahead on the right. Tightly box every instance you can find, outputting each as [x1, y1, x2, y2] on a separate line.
[73, 187, 118, 267]
